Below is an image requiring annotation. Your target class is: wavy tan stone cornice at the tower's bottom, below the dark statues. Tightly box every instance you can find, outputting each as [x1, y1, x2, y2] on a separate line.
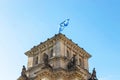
[36, 68, 87, 80]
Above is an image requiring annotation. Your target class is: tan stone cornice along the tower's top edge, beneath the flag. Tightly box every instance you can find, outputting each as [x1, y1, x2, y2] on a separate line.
[25, 33, 91, 58]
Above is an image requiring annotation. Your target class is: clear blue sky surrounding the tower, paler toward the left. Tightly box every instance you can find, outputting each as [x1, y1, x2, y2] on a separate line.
[0, 0, 120, 80]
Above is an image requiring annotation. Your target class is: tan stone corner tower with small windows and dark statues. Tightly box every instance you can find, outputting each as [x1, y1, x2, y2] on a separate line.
[17, 33, 96, 80]
